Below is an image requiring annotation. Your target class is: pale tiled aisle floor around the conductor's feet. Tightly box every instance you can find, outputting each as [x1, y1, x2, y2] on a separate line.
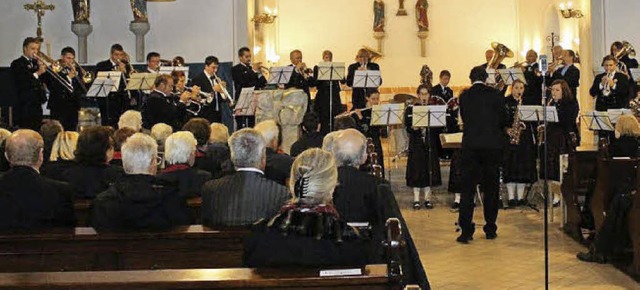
[385, 140, 640, 290]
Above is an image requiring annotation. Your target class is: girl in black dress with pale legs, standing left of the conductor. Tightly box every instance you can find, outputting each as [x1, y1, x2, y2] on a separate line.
[404, 85, 442, 209]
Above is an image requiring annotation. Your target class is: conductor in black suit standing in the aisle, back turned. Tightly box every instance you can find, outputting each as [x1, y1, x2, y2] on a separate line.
[457, 66, 507, 244]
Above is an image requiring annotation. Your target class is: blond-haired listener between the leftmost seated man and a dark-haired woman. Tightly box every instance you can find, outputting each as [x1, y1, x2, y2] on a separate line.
[40, 131, 78, 181]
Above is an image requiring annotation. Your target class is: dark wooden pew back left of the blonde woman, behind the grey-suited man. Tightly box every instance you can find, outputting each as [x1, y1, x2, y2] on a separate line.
[0, 225, 249, 272]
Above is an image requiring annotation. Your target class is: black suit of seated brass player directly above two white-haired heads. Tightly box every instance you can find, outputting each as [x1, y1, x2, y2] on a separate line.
[142, 91, 187, 132]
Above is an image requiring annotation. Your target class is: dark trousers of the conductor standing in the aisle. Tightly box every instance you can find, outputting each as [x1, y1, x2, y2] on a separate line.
[458, 148, 502, 236]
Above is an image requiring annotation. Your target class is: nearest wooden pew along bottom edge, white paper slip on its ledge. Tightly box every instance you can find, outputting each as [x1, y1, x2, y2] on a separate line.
[0, 265, 399, 290]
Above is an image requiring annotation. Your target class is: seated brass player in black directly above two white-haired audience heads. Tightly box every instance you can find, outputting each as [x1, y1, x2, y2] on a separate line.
[144, 75, 191, 131]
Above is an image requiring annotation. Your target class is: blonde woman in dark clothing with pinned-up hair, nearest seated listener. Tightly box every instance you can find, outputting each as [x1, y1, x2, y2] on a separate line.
[244, 148, 371, 267]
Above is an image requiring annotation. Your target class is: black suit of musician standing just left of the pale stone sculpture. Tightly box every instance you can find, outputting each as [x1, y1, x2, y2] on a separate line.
[231, 63, 267, 130]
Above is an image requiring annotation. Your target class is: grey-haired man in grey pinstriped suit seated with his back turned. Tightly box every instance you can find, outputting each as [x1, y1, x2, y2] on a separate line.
[202, 128, 291, 227]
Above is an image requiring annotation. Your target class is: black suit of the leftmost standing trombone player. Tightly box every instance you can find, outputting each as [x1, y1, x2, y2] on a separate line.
[11, 56, 47, 131]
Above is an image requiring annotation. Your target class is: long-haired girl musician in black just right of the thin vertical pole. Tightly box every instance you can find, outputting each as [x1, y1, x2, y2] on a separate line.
[540, 80, 578, 206]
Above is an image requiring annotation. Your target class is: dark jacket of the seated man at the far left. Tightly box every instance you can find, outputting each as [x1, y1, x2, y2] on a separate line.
[0, 166, 75, 230]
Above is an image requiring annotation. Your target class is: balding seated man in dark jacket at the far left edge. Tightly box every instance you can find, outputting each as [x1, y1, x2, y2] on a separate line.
[0, 130, 75, 230]
